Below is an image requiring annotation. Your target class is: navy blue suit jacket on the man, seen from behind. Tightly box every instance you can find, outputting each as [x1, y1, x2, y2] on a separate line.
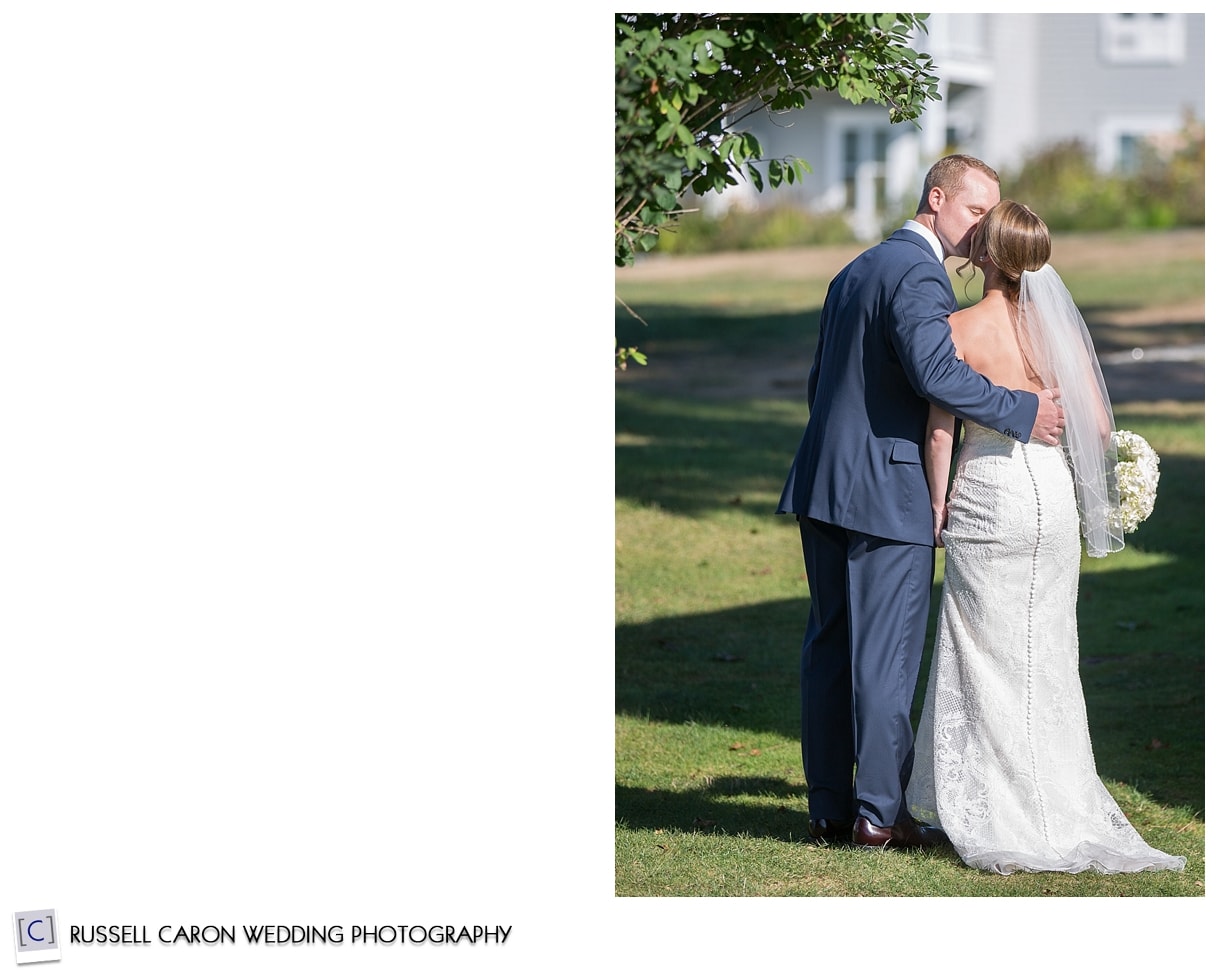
[777, 229, 1039, 546]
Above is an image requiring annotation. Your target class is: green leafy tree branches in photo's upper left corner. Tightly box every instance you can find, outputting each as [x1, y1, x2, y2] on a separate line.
[614, 13, 939, 266]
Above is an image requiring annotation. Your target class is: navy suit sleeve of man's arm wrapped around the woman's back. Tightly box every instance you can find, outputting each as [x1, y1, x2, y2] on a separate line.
[889, 261, 1039, 442]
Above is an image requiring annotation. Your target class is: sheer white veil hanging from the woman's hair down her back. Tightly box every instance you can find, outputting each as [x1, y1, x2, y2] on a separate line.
[1019, 263, 1125, 557]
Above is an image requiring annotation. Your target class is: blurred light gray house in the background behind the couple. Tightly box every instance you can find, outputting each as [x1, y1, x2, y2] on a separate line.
[697, 13, 1205, 239]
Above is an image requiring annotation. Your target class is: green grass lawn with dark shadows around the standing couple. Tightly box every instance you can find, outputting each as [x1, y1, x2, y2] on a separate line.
[615, 231, 1205, 897]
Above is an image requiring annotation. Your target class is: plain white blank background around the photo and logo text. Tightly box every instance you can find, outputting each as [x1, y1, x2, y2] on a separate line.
[0, 0, 1208, 969]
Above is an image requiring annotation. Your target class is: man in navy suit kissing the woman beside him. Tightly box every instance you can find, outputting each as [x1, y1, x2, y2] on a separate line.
[777, 155, 1062, 848]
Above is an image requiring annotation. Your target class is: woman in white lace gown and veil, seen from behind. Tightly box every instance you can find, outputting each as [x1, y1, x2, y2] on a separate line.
[906, 200, 1185, 874]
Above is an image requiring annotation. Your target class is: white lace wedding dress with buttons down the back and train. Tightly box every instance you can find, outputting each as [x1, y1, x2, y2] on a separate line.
[906, 423, 1185, 874]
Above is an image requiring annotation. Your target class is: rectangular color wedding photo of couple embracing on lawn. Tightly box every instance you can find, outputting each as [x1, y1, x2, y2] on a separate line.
[614, 12, 1206, 966]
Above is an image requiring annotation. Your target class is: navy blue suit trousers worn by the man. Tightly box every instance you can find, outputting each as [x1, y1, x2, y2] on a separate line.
[799, 517, 934, 826]
